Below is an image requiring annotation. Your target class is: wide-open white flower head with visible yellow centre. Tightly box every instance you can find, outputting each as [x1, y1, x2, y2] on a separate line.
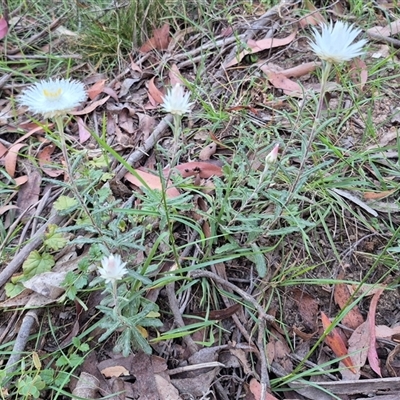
[18, 79, 87, 118]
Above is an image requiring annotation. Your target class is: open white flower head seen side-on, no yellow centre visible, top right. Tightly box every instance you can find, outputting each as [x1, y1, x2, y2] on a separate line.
[310, 21, 367, 64]
